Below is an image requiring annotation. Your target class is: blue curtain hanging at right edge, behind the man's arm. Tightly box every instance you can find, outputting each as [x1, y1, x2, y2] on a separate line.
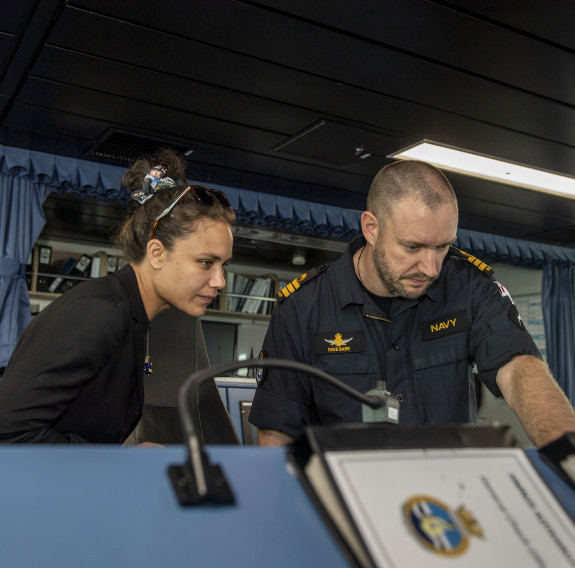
[541, 264, 575, 405]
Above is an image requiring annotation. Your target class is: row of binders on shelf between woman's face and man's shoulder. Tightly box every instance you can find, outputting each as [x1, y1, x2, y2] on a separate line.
[224, 272, 277, 314]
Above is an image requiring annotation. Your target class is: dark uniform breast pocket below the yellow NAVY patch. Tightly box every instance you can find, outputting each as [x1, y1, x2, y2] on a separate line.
[411, 333, 472, 424]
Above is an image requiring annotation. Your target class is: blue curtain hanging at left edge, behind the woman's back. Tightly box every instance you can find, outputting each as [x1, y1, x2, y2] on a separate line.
[0, 173, 50, 367]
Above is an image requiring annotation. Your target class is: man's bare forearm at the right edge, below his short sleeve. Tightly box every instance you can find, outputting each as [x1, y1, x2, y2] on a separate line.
[497, 355, 575, 446]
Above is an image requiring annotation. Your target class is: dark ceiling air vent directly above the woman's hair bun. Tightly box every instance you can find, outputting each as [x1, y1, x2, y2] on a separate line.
[89, 130, 190, 162]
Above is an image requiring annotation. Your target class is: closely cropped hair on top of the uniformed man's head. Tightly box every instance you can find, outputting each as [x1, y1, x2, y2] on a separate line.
[367, 160, 457, 222]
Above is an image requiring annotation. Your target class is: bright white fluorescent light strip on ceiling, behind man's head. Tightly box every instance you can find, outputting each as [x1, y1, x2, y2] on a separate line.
[387, 140, 575, 199]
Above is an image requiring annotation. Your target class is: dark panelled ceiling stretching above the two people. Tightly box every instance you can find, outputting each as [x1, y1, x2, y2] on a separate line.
[0, 0, 575, 258]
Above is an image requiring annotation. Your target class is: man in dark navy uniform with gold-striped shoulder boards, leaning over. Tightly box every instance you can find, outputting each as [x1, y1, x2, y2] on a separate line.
[250, 161, 575, 445]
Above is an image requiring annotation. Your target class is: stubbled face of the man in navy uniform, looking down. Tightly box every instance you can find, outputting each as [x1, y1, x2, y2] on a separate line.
[373, 197, 457, 300]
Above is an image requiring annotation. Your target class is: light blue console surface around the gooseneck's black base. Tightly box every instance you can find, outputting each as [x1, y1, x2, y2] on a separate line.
[0, 446, 348, 568]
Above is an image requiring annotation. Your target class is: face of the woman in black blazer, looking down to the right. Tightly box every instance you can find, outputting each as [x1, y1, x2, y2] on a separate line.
[154, 220, 233, 316]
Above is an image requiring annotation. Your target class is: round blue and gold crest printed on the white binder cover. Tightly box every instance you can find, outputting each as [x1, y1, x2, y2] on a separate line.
[403, 495, 483, 556]
